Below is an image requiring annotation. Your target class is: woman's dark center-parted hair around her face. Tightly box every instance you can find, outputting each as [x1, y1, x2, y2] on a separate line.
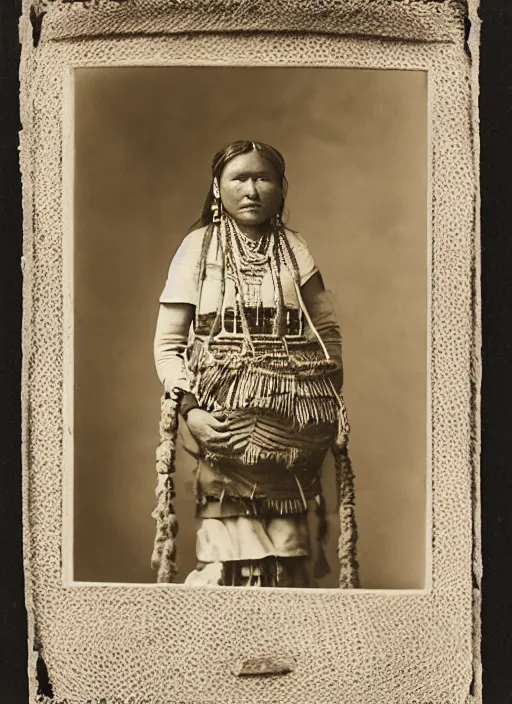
[192, 140, 288, 229]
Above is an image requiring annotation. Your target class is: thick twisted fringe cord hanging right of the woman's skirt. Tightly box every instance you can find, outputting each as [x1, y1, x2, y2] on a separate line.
[333, 437, 360, 589]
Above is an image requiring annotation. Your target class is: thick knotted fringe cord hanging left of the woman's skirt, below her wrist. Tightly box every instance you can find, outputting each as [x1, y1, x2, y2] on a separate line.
[151, 388, 184, 583]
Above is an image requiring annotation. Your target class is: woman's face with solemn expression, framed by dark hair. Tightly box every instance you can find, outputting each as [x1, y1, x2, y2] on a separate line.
[219, 150, 283, 226]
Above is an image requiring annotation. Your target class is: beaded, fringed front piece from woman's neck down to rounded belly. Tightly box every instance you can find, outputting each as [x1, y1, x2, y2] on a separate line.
[187, 216, 348, 471]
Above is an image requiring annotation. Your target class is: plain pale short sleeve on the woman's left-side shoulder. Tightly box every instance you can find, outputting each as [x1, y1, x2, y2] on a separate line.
[160, 230, 204, 305]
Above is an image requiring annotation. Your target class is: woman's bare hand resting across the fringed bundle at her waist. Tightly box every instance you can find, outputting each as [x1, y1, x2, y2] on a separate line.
[187, 408, 253, 453]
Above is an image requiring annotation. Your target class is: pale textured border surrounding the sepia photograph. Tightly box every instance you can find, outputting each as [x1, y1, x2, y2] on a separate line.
[21, 0, 481, 704]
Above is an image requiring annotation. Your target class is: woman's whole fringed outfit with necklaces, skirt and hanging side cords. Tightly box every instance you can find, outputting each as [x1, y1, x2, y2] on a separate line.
[153, 215, 358, 588]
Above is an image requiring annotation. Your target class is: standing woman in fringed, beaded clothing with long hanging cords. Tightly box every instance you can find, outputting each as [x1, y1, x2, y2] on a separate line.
[153, 141, 357, 587]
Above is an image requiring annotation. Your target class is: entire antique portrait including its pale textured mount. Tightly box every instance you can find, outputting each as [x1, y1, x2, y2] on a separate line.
[20, 0, 481, 704]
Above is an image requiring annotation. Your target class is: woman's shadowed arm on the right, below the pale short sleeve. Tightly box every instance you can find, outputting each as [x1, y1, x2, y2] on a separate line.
[301, 271, 343, 391]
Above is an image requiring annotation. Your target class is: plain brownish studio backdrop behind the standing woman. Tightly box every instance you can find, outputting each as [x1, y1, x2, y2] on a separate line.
[74, 67, 429, 589]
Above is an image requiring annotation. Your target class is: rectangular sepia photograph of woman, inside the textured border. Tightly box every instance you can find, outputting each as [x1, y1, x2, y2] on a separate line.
[68, 66, 431, 590]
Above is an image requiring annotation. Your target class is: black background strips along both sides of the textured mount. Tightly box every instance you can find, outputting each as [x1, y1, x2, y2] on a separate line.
[0, 0, 512, 704]
